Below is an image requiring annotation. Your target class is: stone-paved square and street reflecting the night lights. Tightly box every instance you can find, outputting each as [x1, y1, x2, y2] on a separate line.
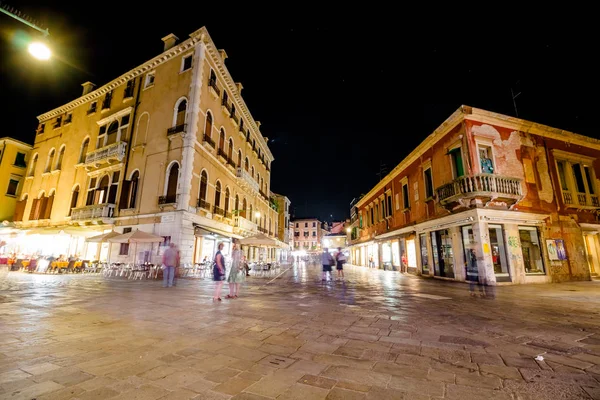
[0, 265, 600, 400]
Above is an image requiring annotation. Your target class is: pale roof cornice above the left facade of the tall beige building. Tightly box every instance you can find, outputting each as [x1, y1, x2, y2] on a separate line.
[37, 32, 204, 122]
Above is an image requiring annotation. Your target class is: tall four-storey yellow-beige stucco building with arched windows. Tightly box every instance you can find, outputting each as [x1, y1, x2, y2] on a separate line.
[12, 28, 277, 262]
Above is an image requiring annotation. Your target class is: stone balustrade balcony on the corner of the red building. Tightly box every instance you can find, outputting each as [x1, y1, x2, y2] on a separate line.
[436, 174, 523, 209]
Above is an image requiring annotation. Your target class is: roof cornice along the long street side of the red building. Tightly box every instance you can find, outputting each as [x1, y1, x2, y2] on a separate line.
[354, 106, 465, 208]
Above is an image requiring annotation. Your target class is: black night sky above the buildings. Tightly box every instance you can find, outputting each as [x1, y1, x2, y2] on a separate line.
[0, 4, 600, 220]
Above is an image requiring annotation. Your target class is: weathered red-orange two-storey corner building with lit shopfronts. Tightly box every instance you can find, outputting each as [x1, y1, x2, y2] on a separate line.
[350, 106, 600, 285]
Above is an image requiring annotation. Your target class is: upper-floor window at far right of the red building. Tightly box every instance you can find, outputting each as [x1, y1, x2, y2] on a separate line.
[552, 150, 600, 208]
